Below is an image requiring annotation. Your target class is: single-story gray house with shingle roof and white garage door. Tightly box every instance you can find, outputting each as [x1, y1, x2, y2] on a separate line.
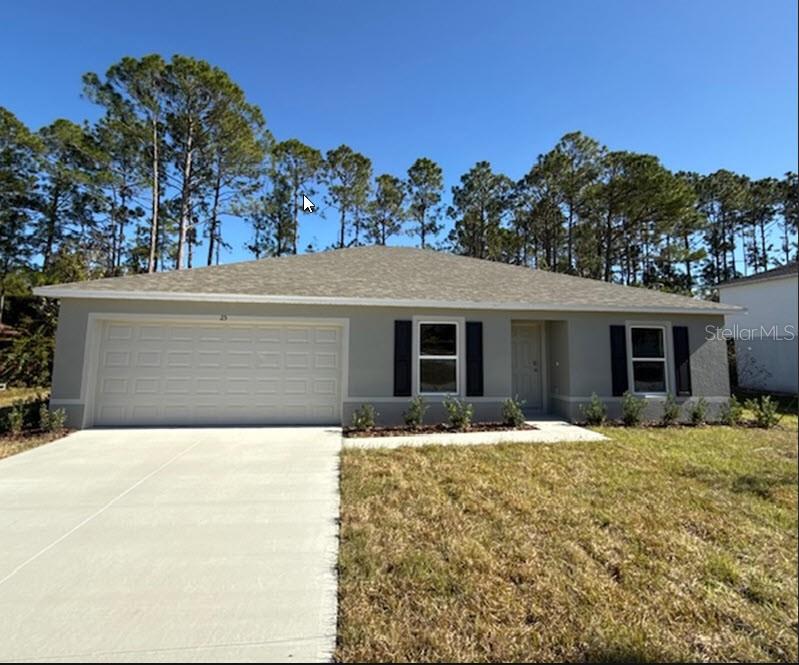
[36, 247, 735, 427]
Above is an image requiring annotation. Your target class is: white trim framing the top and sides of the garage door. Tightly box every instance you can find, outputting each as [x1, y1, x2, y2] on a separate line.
[76, 312, 350, 429]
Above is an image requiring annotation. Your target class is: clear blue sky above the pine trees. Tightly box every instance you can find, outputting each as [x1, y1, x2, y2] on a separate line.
[0, 0, 798, 260]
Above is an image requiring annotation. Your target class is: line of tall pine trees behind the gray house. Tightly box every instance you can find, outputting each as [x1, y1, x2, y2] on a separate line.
[0, 50, 797, 320]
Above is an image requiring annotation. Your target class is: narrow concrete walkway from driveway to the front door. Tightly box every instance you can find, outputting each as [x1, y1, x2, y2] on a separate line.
[343, 419, 607, 448]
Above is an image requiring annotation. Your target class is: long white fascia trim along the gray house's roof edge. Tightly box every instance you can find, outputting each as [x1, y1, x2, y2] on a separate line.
[33, 286, 744, 316]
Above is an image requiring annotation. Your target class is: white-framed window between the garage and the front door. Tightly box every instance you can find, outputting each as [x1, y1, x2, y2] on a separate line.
[419, 322, 458, 394]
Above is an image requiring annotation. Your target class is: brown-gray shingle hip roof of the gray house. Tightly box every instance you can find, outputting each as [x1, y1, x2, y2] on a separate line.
[36, 246, 737, 313]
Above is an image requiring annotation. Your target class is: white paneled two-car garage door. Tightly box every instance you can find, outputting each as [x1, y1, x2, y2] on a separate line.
[93, 321, 342, 426]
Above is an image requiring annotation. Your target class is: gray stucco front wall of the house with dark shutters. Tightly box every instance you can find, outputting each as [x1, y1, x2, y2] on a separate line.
[47, 299, 729, 426]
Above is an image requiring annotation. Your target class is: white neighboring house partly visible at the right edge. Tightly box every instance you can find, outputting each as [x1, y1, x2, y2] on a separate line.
[719, 261, 799, 393]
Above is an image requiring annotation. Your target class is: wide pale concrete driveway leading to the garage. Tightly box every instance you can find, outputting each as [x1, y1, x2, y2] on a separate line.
[0, 428, 341, 662]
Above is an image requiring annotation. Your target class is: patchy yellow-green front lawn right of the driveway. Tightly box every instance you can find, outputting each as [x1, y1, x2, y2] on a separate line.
[336, 418, 797, 662]
